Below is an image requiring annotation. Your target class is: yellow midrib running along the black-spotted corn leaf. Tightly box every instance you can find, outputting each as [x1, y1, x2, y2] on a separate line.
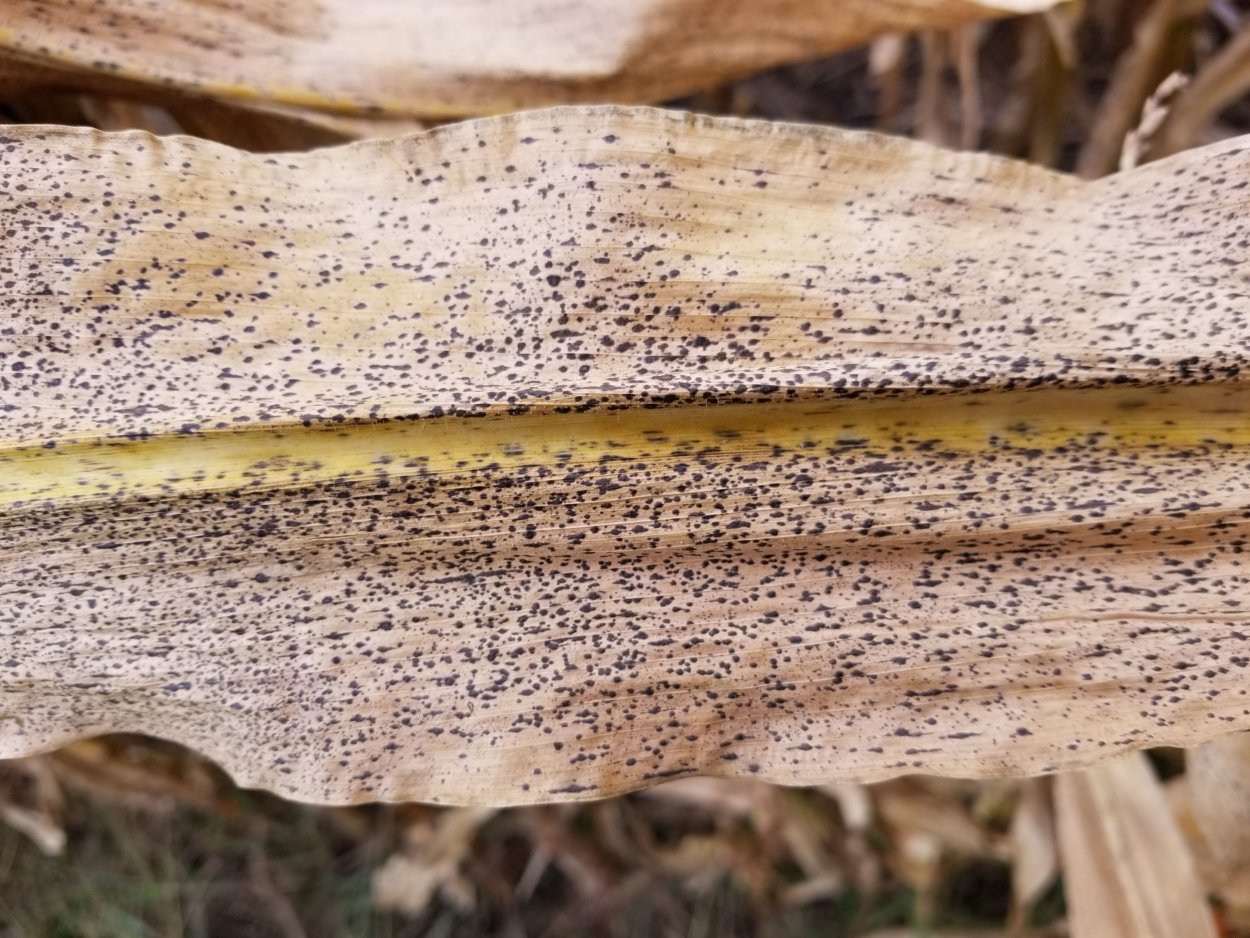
[0, 383, 1250, 510]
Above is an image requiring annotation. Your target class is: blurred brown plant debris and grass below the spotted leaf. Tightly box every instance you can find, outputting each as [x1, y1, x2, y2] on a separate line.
[0, 737, 1065, 938]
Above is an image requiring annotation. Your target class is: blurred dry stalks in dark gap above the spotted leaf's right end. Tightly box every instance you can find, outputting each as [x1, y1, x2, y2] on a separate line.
[715, 6, 1250, 178]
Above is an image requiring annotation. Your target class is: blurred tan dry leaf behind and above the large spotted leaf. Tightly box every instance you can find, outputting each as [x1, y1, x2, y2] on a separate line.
[0, 0, 1056, 116]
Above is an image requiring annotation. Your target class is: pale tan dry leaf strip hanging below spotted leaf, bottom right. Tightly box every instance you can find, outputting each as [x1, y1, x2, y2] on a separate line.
[1055, 753, 1216, 938]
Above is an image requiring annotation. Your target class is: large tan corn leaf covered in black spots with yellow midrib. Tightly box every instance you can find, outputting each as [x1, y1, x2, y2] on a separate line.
[0, 109, 1250, 804]
